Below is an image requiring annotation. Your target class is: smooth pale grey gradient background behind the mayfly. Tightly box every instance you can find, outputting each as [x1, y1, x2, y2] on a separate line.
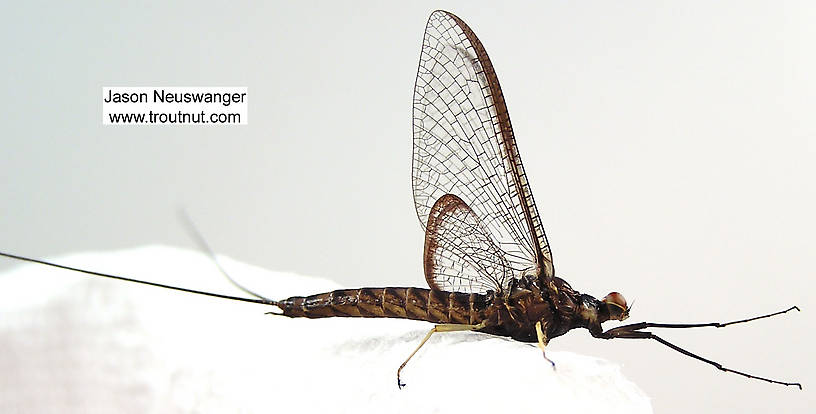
[0, 1, 816, 413]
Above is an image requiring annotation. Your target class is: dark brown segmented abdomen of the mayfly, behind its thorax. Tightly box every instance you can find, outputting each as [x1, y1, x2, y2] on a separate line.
[278, 287, 491, 325]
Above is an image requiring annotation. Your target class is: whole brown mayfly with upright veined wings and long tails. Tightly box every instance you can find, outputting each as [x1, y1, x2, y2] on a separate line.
[0, 11, 802, 389]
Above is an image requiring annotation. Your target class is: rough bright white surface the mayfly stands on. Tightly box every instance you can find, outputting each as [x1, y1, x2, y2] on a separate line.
[0, 247, 651, 414]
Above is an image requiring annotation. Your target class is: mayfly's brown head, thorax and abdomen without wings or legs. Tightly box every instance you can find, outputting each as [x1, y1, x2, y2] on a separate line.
[275, 277, 628, 342]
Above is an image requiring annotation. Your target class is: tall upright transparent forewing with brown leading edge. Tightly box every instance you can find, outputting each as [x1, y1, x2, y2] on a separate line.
[412, 11, 553, 291]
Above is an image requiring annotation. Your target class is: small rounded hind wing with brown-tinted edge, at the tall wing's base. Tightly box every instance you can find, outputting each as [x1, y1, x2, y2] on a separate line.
[424, 194, 512, 293]
